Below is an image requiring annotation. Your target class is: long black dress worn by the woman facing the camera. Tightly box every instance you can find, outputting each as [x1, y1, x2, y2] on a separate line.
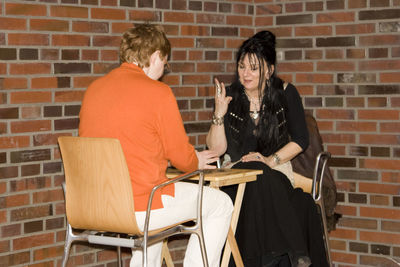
[223, 84, 329, 267]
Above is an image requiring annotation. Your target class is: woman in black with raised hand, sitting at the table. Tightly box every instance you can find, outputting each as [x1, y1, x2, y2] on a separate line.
[207, 31, 329, 267]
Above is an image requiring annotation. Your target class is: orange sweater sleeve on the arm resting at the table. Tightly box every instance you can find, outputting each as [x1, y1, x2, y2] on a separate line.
[158, 88, 198, 172]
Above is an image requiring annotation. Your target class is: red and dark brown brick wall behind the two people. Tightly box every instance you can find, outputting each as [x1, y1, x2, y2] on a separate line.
[0, 0, 400, 266]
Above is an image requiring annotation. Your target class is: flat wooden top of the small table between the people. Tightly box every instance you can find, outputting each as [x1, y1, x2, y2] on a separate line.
[167, 168, 263, 187]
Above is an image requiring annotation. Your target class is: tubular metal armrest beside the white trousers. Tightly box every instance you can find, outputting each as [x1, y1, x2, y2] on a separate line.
[143, 170, 204, 239]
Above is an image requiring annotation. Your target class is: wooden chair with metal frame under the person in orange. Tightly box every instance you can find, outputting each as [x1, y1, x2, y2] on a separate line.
[58, 136, 208, 267]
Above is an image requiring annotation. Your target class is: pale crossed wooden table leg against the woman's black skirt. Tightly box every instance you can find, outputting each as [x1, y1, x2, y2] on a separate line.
[221, 183, 246, 267]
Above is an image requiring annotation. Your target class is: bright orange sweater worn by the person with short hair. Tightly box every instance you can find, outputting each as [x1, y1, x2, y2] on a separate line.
[79, 63, 198, 211]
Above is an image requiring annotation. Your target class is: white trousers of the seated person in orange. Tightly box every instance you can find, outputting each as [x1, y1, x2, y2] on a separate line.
[130, 182, 233, 267]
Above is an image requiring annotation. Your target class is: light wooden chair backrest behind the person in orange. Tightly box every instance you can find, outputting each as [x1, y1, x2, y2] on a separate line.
[58, 136, 140, 234]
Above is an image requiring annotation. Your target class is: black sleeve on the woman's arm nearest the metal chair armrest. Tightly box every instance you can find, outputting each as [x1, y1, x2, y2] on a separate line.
[285, 84, 309, 151]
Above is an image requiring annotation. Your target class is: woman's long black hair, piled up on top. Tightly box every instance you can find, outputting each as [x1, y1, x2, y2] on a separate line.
[228, 31, 289, 155]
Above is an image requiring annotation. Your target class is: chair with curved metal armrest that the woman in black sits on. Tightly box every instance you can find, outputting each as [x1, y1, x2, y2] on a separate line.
[294, 151, 332, 265]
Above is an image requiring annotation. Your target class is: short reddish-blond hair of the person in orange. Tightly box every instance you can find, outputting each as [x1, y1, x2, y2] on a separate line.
[119, 23, 171, 68]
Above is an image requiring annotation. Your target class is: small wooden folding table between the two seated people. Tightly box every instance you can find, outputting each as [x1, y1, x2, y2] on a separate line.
[163, 169, 262, 267]
